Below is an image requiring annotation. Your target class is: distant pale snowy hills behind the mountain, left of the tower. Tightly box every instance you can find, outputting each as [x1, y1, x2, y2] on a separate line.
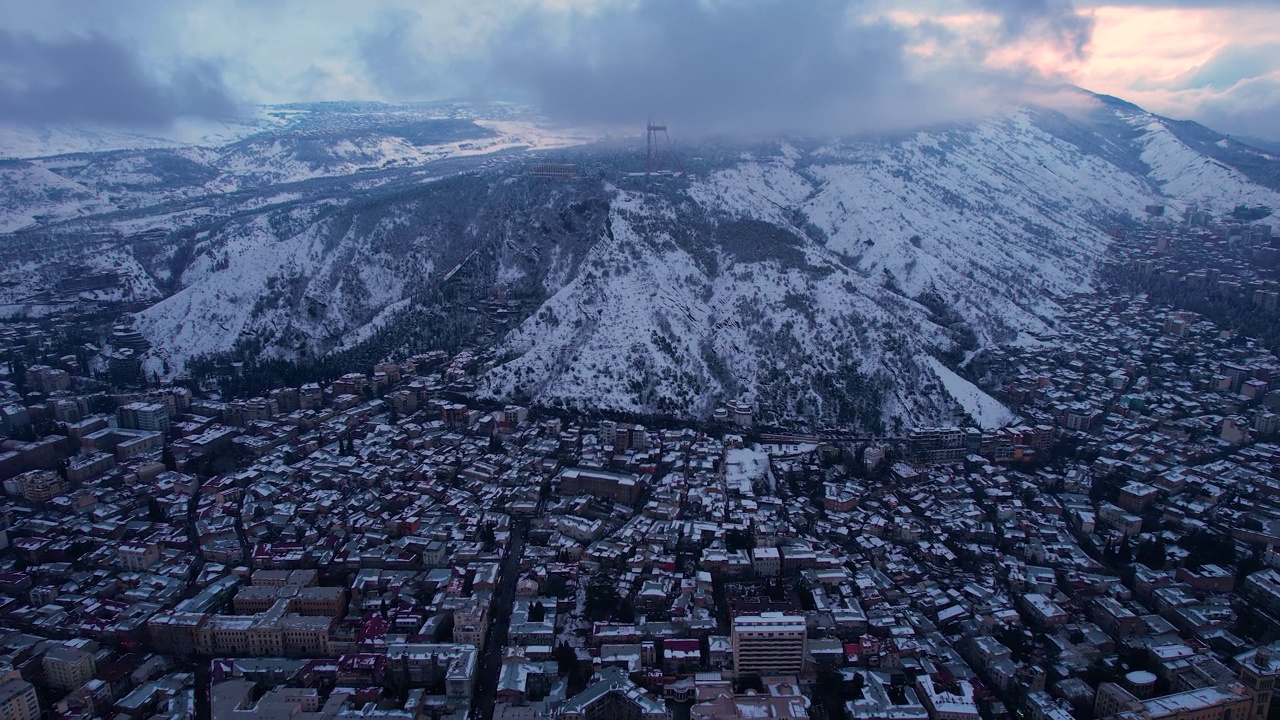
[0, 104, 591, 233]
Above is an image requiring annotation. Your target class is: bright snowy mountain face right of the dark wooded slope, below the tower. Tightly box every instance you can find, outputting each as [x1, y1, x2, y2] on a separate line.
[486, 107, 1172, 428]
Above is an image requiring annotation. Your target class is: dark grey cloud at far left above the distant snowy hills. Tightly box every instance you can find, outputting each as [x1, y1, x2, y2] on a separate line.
[0, 29, 237, 127]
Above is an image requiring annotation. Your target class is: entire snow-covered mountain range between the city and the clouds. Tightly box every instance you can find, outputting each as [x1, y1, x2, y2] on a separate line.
[0, 96, 1280, 429]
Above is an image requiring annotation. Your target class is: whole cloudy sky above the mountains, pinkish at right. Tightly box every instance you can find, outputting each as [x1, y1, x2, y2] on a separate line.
[0, 0, 1280, 140]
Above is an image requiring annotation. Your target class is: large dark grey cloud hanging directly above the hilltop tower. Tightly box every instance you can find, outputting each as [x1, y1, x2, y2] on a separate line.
[493, 0, 911, 127]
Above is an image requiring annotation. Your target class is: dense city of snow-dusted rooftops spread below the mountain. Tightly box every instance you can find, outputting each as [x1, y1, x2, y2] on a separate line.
[0, 206, 1280, 720]
